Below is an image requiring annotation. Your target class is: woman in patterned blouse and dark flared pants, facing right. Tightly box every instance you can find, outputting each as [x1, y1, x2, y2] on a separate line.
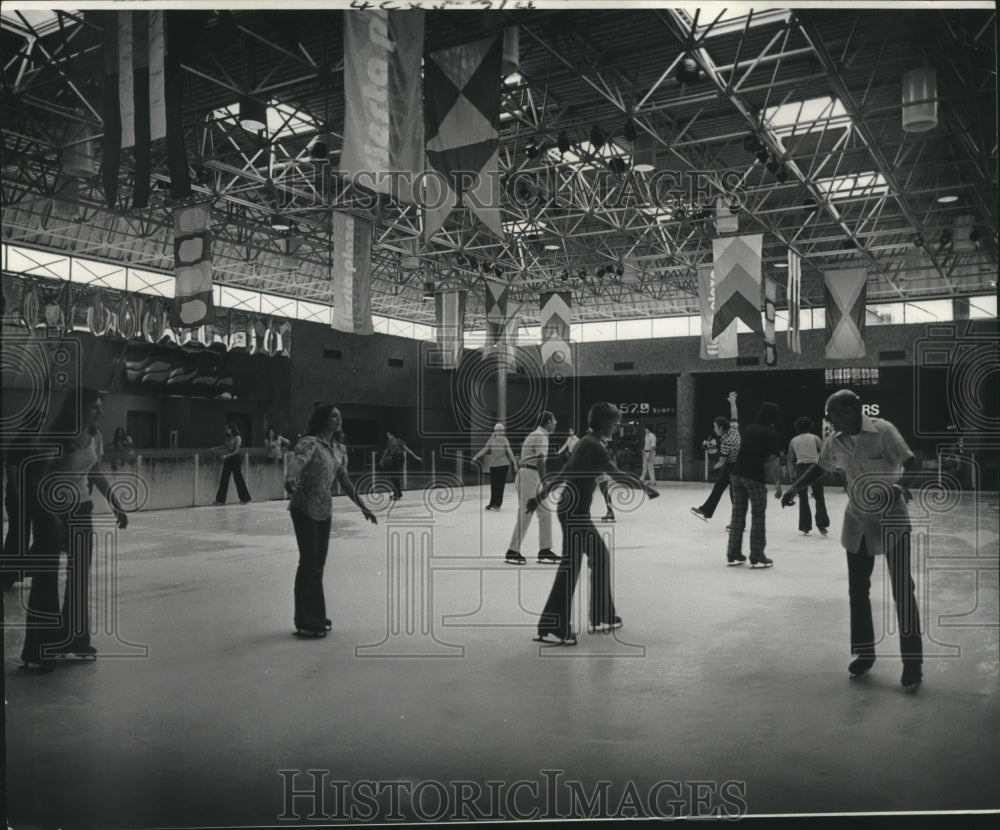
[285, 403, 378, 637]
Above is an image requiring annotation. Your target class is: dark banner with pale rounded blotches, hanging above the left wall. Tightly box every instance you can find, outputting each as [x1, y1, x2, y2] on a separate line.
[171, 202, 215, 327]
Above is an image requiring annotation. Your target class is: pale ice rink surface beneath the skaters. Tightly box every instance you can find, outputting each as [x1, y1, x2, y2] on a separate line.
[4, 484, 1000, 829]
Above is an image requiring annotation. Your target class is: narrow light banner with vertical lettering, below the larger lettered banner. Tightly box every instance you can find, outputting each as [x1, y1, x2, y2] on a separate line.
[333, 211, 375, 334]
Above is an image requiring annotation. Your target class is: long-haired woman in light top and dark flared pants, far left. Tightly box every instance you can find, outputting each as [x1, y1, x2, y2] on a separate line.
[21, 389, 128, 672]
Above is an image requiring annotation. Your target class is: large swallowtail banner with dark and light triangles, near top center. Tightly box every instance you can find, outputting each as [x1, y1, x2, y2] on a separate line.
[424, 36, 503, 244]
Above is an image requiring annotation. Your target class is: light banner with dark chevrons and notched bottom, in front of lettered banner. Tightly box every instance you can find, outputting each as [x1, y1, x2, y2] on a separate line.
[712, 233, 764, 337]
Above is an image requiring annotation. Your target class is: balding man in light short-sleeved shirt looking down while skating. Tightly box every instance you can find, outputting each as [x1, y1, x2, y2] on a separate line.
[781, 389, 923, 692]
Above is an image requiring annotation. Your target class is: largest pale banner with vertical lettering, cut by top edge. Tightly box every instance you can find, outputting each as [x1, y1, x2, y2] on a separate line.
[340, 9, 424, 202]
